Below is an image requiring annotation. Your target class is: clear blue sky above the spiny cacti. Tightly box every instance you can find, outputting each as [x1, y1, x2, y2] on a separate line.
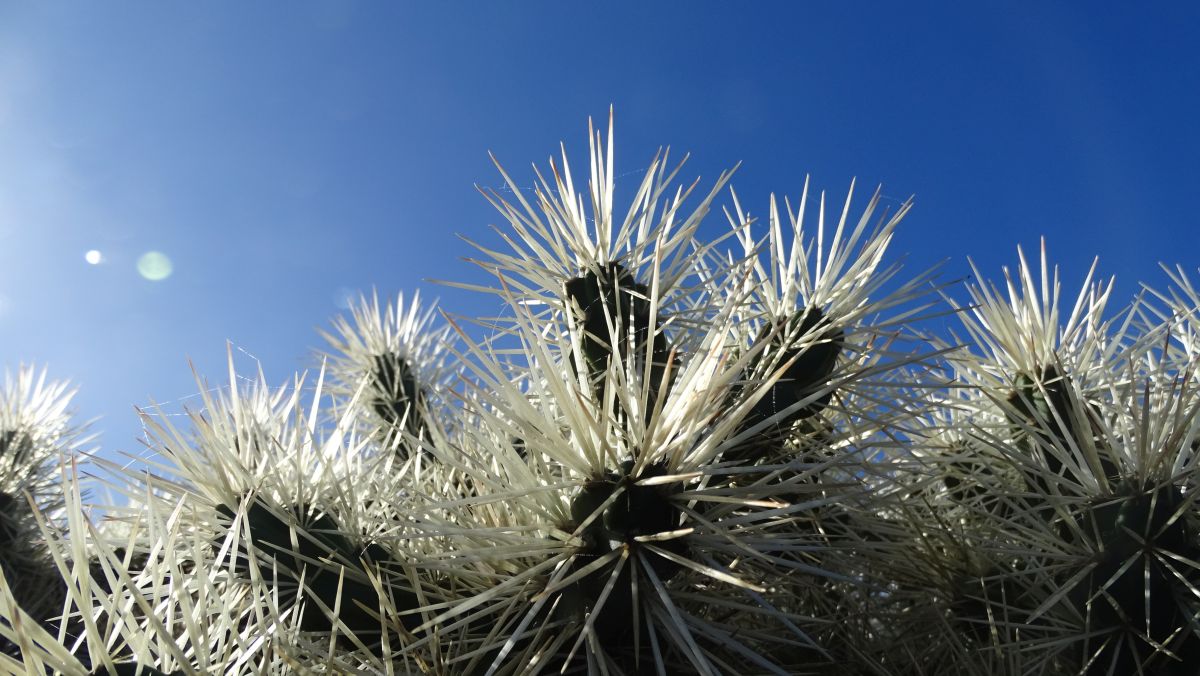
[0, 0, 1200, 465]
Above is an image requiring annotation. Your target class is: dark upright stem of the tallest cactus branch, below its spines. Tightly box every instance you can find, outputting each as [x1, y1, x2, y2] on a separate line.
[566, 263, 671, 411]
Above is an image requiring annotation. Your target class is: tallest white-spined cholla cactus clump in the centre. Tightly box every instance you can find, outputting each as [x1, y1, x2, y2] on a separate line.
[417, 116, 950, 674]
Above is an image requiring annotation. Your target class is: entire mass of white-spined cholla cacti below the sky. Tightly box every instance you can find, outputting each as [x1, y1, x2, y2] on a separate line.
[0, 116, 1200, 676]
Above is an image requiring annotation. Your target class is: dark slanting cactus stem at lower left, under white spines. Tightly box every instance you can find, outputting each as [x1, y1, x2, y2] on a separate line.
[212, 499, 420, 647]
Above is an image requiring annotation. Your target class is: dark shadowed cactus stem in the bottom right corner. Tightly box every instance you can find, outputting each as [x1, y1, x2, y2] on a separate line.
[1070, 485, 1200, 676]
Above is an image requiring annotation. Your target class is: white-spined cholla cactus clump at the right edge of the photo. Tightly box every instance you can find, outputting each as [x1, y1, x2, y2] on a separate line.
[892, 252, 1200, 676]
